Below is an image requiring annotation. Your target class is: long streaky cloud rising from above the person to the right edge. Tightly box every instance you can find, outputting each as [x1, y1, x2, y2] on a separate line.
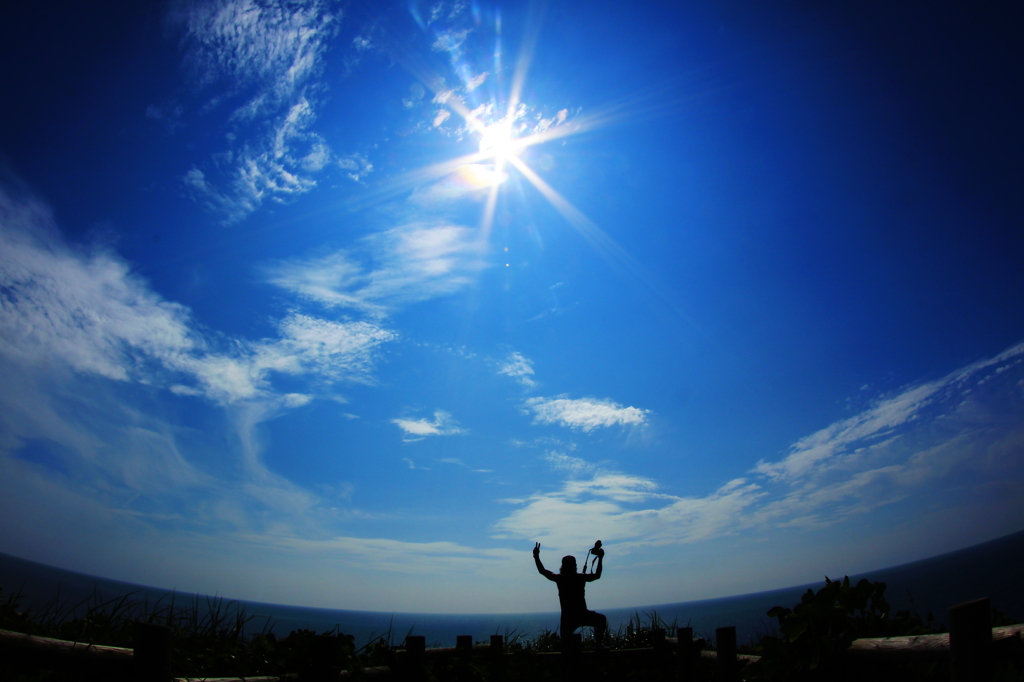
[495, 343, 1024, 552]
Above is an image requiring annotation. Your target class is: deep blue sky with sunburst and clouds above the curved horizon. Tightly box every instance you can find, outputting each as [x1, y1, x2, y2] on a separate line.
[0, 0, 1024, 612]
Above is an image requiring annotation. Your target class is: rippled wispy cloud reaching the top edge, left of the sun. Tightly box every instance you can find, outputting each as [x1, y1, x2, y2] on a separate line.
[172, 0, 372, 223]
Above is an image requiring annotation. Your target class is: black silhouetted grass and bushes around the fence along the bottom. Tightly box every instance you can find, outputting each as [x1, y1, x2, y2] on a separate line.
[0, 580, 1024, 682]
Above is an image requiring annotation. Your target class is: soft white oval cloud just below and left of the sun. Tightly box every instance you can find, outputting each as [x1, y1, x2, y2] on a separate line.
[268, 223, 485, 315]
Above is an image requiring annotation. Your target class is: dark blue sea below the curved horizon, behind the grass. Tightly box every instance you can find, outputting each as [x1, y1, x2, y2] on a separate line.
[0, 531, 1024, 646]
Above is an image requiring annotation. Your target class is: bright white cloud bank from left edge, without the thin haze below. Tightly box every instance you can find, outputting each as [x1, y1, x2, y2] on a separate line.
[0, 183, 395, 404]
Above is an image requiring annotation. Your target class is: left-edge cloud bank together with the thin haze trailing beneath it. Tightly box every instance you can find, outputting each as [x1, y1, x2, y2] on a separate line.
[0, 179, 395, 532]
